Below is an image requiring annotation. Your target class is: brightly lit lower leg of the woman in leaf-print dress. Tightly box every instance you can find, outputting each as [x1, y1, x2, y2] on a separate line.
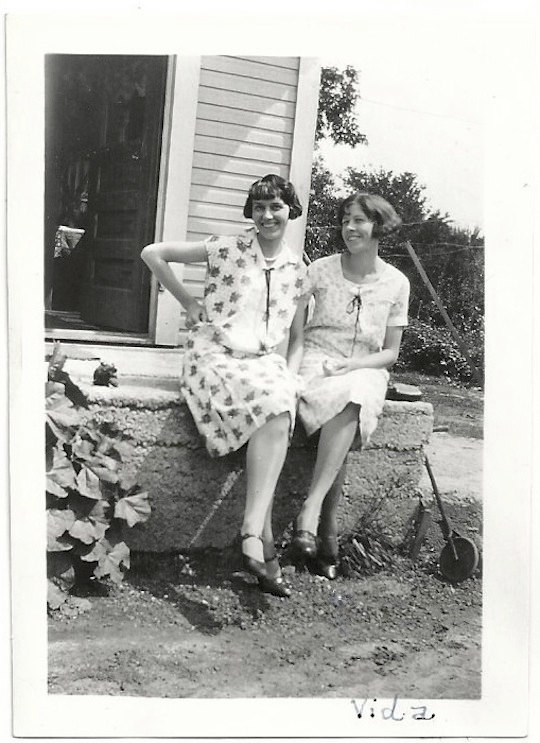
[241, 413, 290, 562]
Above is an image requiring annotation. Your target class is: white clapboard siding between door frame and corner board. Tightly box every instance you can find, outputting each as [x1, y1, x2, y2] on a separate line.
[180, 56, 299, 340]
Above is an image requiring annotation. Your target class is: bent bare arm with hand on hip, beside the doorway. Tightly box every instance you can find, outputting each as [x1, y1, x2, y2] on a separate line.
[141, 242, 207, 325]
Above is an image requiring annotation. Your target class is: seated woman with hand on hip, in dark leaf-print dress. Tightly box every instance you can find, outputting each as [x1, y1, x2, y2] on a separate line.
[142, 175, 305, 596]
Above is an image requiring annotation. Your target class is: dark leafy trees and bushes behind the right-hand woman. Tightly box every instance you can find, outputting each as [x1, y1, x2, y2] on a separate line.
[306, 67, 484, 379]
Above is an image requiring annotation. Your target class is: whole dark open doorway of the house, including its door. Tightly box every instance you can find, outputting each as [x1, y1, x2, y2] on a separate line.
[44, 54, 167, 337]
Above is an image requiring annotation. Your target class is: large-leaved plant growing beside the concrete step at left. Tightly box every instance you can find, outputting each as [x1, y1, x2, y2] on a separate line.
[46, 346, 151, 608]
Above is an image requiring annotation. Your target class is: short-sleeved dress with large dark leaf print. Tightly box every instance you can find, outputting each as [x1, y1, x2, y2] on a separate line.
[182, 230, 306, 456]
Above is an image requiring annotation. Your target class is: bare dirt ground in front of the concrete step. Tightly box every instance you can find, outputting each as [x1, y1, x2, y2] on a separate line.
[49, 385, 482, 699]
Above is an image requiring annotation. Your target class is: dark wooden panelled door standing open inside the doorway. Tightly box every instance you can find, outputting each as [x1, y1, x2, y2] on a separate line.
[81, 55, 167, 333]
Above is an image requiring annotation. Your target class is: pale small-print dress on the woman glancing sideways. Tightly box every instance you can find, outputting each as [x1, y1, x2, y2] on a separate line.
[298, 254, 409, 445]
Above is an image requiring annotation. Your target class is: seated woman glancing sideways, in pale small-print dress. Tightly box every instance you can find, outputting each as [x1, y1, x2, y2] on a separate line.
[293, 193, 409, 578]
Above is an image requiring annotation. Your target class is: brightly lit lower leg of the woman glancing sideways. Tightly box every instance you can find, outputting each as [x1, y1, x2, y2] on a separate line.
[296, 403, 359, 534]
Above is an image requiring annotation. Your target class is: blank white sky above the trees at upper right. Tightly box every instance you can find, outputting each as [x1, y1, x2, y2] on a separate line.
[320, 29, 489, 229]
